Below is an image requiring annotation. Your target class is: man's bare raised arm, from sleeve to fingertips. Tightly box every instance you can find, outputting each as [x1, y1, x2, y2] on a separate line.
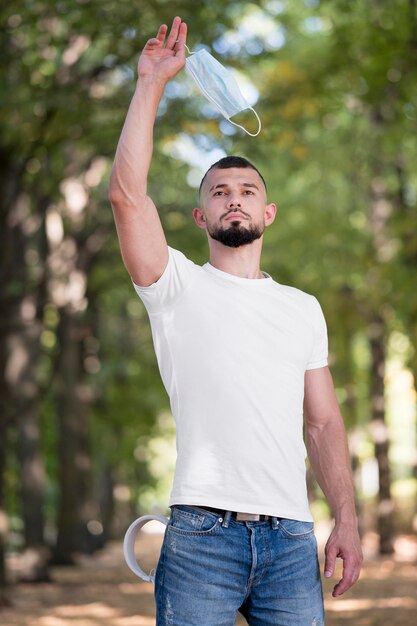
[109, 17, 187, 286]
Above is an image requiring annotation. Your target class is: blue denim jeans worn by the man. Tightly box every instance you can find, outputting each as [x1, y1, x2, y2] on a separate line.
[155, 505, 324, 626]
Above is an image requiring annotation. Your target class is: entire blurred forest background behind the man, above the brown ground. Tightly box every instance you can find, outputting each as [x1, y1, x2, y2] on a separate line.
[0, 0, 417, 623]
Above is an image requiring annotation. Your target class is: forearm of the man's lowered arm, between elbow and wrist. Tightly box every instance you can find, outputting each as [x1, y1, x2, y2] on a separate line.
[307, 413, 357, 525]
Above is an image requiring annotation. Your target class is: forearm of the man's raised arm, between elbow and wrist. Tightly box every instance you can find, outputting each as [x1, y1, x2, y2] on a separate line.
[109, 76, 166, 207]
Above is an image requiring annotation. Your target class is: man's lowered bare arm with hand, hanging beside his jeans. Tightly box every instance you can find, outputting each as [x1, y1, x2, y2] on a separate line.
[304, 367, 362, 596]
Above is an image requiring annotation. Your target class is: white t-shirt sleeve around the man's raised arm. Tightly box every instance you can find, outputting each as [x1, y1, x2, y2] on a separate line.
[132, 247, 197, 314]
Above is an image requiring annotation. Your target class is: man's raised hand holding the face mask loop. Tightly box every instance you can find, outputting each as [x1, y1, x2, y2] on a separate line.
[138, 17, 187, 81]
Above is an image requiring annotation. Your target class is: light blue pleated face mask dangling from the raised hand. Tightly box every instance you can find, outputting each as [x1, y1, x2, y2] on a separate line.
[185, 48, 262, 137]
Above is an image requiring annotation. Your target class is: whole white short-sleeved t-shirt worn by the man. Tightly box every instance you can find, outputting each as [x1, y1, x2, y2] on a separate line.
[134, 248, 327, 521]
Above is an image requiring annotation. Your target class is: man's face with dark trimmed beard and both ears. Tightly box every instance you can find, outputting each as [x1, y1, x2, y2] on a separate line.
[194, 168, 275, 248]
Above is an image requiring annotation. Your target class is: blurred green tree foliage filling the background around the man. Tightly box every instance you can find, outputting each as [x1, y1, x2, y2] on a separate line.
[0, 0, 417, 560]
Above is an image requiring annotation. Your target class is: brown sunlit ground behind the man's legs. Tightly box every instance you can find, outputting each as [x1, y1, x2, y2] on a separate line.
[0, 535, 417, 626]
